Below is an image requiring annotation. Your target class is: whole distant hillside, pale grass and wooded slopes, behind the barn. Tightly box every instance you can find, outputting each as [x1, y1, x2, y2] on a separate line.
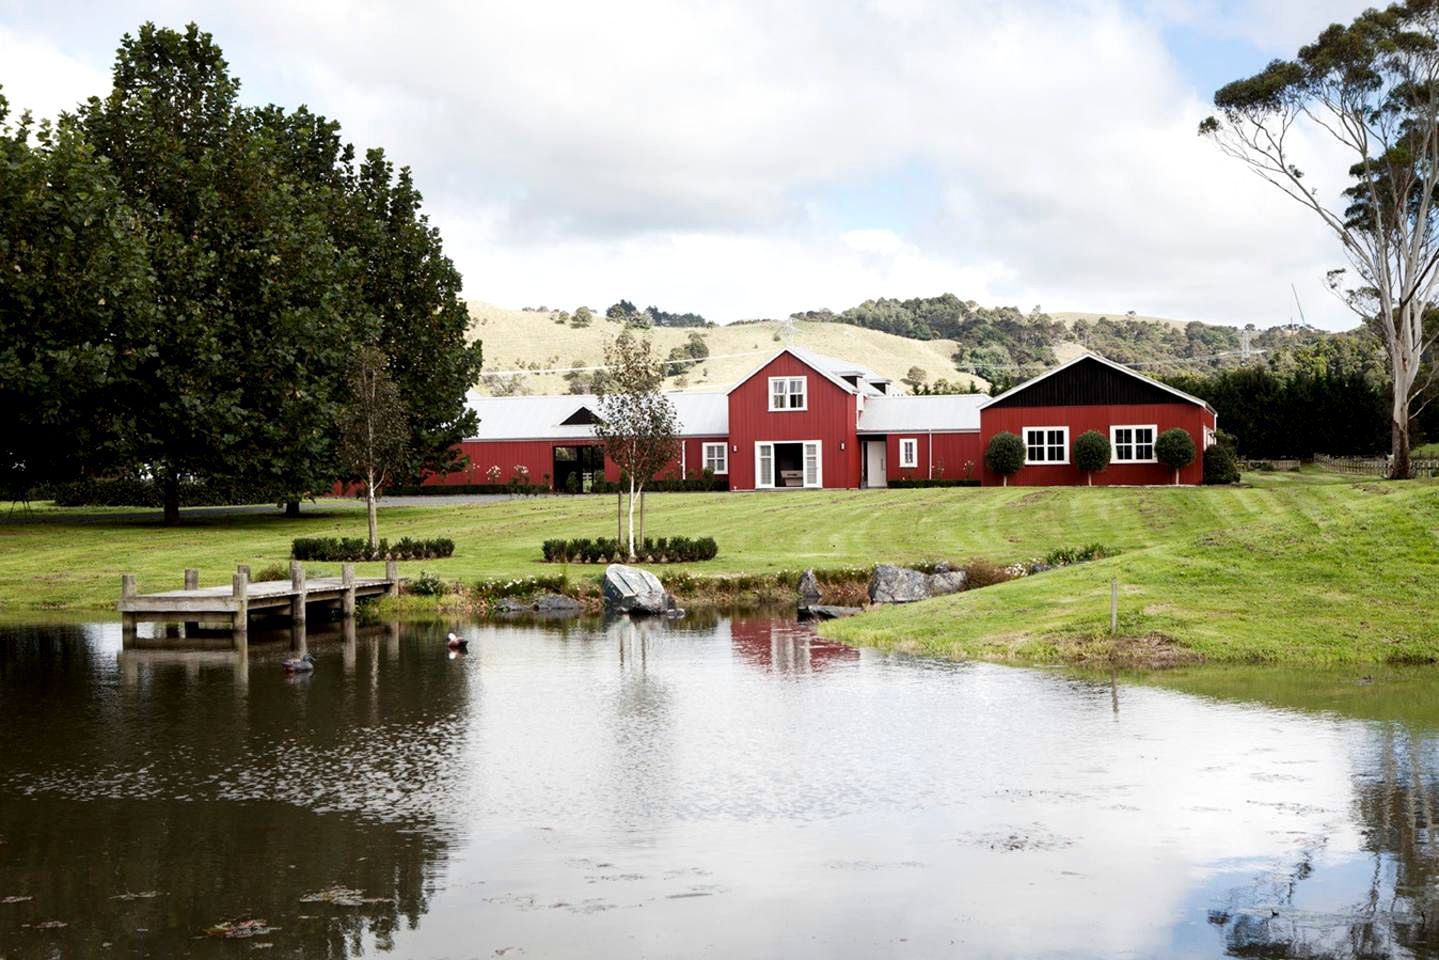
[469, 294, 1356, 393]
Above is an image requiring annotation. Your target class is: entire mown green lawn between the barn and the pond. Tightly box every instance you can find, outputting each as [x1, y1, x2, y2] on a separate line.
[8, 472, 1439, 662]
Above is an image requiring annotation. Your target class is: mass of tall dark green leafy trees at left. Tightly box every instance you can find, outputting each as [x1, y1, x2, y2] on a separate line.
[0, 23, 481, 522]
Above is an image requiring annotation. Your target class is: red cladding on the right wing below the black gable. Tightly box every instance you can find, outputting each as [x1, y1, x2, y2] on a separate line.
[980, 400, 1215, 486]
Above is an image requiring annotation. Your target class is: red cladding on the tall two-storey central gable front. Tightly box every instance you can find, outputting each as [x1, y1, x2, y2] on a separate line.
[730, 353, 859, 489]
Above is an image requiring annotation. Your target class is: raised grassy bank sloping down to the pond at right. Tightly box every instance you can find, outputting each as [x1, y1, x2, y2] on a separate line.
[823, 472, 1439, 664]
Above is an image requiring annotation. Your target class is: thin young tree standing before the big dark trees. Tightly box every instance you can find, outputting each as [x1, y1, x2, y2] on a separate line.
[340, 347, 410, 553]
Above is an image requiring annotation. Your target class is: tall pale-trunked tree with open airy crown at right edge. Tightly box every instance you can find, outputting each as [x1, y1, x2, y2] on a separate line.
[1200, 0, 1439, 478]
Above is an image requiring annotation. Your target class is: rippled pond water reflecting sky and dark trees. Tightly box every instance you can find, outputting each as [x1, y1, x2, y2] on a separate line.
[0, 616, 1439, 960]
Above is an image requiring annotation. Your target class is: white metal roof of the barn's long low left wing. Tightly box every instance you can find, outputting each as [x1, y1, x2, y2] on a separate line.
[465, 393, 730, 440]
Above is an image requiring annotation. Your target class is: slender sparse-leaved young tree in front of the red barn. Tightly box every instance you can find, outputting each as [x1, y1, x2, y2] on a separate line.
[594, 331, 679, 560]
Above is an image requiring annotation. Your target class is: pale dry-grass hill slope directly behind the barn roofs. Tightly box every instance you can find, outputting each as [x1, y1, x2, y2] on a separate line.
[469, 302, 989, 394]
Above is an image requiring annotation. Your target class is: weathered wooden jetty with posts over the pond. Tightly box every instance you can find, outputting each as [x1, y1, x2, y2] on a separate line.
[118, 560, 400, 649]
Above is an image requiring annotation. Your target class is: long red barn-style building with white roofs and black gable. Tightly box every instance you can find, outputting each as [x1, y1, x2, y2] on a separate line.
[429, 347, 1215, 491]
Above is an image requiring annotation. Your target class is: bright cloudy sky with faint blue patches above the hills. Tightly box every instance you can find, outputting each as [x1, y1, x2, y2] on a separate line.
[0, 0, 1368, 327]
